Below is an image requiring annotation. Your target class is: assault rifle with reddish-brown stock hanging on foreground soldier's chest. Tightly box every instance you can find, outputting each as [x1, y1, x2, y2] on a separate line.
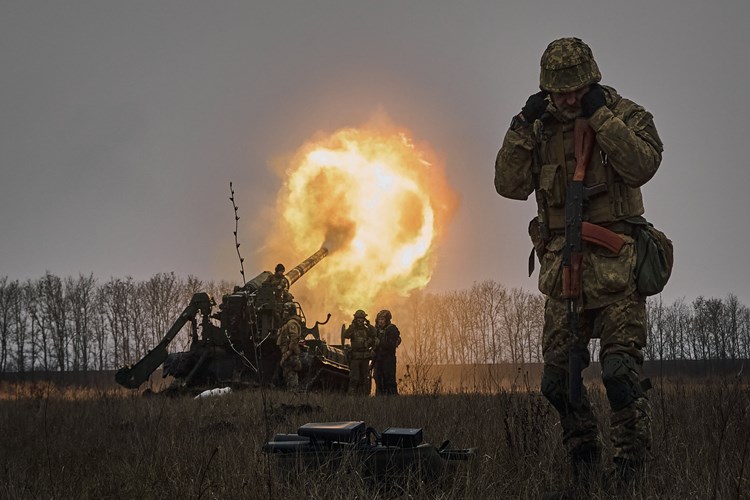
[562, 118, 625, 408]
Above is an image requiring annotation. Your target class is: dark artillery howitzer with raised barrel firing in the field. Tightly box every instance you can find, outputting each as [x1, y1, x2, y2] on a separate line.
[115, 247, 349, 390]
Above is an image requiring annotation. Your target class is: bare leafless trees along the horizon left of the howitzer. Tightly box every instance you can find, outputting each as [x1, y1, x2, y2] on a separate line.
[0, 272, 232, 373]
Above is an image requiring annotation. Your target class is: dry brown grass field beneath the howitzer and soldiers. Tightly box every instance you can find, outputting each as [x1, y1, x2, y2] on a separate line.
[0, 377, 750, 499]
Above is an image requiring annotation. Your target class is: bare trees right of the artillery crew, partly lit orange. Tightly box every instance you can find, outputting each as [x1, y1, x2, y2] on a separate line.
[399, 281, 750, 364]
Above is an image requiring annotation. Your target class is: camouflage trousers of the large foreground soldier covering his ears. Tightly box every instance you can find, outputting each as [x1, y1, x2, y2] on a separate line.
[542, 294, 651, 463]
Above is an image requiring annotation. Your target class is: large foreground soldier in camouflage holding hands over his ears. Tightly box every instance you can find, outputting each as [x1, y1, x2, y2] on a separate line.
[495, 38, 663, 481]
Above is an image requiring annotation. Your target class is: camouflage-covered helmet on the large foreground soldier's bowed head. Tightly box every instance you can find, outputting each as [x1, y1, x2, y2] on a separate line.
[539, 38, 602, 93]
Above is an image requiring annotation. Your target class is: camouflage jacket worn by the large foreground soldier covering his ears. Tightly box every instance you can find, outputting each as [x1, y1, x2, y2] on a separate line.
[495, 86, 663, 308]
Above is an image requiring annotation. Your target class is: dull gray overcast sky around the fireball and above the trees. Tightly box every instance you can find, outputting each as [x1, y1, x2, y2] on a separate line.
[0, 0, 750, 304]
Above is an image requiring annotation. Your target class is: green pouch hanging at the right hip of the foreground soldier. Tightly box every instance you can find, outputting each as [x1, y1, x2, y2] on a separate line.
[627, 217, 674, 296]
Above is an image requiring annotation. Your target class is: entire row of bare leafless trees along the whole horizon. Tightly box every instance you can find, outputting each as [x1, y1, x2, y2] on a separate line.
[0, 273, 750, 373]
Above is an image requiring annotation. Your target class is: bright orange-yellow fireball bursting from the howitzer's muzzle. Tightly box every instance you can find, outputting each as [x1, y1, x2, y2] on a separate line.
[269, 118, 457, 314]
